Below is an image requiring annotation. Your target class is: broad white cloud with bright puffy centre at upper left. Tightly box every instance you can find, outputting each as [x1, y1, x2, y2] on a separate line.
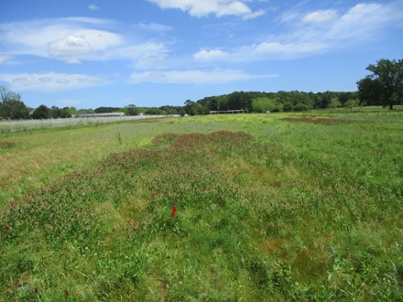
[0, 17, 168, 64]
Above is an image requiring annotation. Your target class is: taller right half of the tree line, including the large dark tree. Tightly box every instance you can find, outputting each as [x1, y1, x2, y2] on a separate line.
[185, 59, 403, 115]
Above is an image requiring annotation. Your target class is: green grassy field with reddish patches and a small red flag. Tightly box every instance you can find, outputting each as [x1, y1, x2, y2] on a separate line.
[0, 109, 403, 301]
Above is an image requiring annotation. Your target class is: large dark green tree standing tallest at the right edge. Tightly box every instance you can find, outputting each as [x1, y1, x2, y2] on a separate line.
[357, 59, 403, 110]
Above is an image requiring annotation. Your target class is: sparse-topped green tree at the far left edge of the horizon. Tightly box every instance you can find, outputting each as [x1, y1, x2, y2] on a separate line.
[0, 86, 29, 119]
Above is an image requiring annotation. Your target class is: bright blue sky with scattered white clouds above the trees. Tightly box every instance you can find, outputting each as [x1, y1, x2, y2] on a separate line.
[0, 0, 403, 109]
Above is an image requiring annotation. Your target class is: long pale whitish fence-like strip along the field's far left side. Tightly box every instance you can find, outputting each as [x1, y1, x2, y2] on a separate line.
[0, 115, 179, 133]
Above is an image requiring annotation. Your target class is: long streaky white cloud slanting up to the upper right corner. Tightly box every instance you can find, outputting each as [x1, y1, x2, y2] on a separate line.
[193, 2, 403, 62]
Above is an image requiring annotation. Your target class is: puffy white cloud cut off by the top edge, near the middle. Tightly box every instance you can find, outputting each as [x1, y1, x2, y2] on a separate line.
[148, 0, 264, 19]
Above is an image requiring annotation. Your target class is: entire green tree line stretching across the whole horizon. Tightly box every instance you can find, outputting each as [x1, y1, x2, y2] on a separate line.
[0, 59, 403, 119]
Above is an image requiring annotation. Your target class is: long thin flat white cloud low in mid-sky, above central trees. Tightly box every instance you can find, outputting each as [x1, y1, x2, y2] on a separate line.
[130, 69, 277, 84]
